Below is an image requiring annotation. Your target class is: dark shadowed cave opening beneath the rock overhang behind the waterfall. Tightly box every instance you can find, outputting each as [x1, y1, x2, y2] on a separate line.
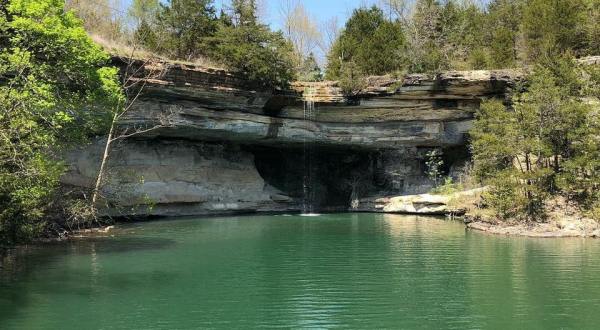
[244, 145, 469, 212]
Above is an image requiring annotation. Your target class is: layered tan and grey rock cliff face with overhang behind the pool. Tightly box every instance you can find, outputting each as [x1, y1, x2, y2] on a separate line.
[63, 60, 519, 215]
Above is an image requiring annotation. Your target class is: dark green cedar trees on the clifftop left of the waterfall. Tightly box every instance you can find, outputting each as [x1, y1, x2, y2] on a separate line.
[132, 0, 295, 87]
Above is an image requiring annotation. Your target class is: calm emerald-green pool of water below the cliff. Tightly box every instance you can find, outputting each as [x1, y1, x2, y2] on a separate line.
[0, 214, 600, 329]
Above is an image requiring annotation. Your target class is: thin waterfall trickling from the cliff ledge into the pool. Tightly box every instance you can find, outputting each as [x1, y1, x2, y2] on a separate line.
[302, 89, 316, 215]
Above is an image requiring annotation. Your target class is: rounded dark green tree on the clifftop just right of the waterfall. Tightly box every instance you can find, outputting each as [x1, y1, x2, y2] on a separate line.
[327, 6, 405, 79]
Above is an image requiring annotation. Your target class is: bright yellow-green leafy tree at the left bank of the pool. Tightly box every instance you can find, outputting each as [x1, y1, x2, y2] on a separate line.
[0, 0, 122, 244]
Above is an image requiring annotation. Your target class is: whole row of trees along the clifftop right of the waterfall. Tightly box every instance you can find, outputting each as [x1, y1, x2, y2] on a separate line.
[327, 0, 600, 74]
